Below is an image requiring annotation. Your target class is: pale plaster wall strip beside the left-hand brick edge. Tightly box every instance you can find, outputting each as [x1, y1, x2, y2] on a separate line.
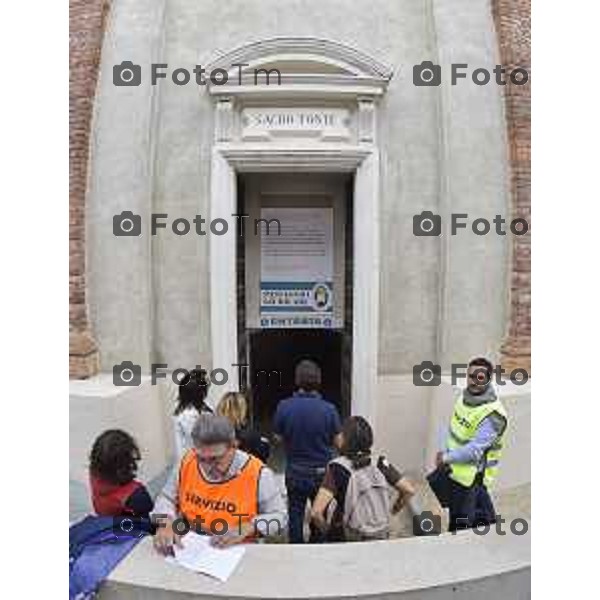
[86, 0, 165, 372]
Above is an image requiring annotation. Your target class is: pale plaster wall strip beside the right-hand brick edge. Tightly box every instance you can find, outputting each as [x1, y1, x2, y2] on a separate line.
[431, 0, 510, 372]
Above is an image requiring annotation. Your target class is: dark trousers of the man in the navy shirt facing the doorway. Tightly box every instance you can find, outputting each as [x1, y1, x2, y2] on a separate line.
[285, 467, 325, 544]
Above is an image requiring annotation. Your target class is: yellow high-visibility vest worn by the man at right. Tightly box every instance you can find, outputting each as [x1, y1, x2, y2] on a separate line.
[447, 394, 508, 488]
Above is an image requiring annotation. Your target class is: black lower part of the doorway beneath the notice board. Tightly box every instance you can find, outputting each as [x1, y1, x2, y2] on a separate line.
[250, 329, 347, 431]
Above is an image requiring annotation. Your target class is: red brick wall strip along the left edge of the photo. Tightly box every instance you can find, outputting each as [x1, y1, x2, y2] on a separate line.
[69, 0, 108, 378]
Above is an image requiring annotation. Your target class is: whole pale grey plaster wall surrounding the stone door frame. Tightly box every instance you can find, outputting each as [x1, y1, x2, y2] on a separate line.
[86, 0, 509, 375]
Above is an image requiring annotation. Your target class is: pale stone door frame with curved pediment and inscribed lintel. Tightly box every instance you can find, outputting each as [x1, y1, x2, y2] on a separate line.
[207, 38, 391, 422]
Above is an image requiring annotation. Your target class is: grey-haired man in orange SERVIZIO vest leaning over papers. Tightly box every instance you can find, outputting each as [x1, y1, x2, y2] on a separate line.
[153, 413, 287, 554]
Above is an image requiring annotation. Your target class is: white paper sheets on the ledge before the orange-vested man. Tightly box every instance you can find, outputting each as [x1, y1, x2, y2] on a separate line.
[167, 531, 246, 582]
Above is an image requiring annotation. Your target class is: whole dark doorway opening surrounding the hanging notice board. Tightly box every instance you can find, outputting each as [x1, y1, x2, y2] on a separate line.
[236, 174, 354, 434]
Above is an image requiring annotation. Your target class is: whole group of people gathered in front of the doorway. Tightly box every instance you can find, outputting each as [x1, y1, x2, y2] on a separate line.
[90, 359, 507, 553]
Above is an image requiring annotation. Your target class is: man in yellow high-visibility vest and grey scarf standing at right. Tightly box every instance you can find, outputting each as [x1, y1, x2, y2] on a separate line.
[436, 357, 508, 531]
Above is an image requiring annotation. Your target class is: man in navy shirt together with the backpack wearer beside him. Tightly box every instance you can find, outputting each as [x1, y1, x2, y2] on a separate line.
[273, 360, 414, 543]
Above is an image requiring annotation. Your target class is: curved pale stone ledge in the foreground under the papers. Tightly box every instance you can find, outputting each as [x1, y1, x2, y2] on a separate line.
[100, 530, 531, 600]
